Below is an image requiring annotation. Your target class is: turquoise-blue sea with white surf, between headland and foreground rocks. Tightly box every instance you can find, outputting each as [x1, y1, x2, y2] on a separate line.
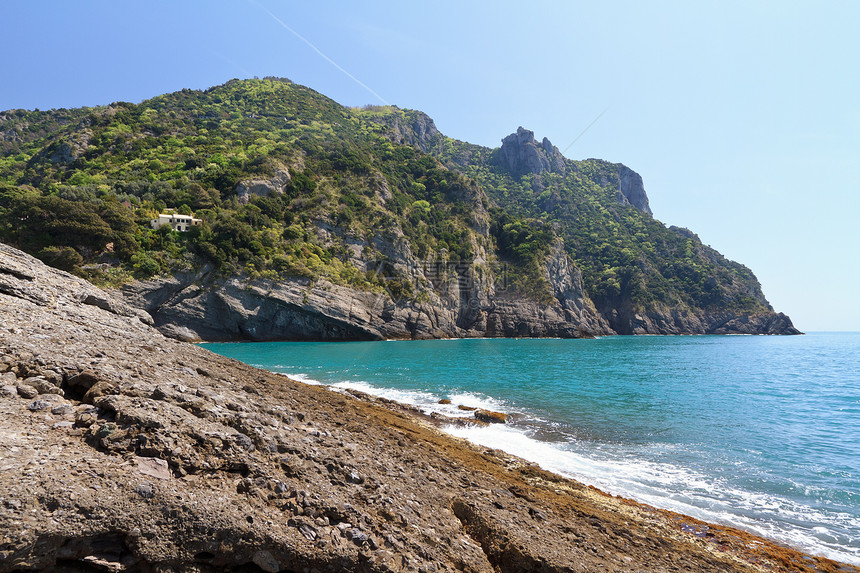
[203, 333, 860, 565]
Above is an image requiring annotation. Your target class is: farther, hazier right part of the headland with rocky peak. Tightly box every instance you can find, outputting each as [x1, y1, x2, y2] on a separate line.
[434, 127, 799, 334]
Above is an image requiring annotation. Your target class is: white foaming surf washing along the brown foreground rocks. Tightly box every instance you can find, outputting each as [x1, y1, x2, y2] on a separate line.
[213, 345, 860, 566]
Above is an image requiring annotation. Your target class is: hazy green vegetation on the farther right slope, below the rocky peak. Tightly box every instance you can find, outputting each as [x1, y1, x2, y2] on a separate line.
[426, 139, 769, 312]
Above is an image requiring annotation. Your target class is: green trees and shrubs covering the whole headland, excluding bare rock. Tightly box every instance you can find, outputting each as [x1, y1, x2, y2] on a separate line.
[0, 78, 767, 320]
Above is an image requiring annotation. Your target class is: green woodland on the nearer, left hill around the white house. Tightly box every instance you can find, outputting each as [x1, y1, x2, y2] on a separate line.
[0, 80, 475, 288]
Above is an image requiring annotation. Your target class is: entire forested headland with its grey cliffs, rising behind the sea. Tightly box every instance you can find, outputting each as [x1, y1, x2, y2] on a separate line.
[0, 79, 797, 340]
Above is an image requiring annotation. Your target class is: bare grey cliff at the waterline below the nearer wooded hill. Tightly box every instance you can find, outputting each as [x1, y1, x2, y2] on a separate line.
[121, 235, 613, 341]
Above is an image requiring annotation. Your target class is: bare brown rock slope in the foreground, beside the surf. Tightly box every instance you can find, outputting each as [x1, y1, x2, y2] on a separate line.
[0, 245, 848, 572]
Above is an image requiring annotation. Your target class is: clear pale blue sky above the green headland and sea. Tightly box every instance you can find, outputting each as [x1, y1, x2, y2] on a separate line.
[0, 0, 860, 331]
